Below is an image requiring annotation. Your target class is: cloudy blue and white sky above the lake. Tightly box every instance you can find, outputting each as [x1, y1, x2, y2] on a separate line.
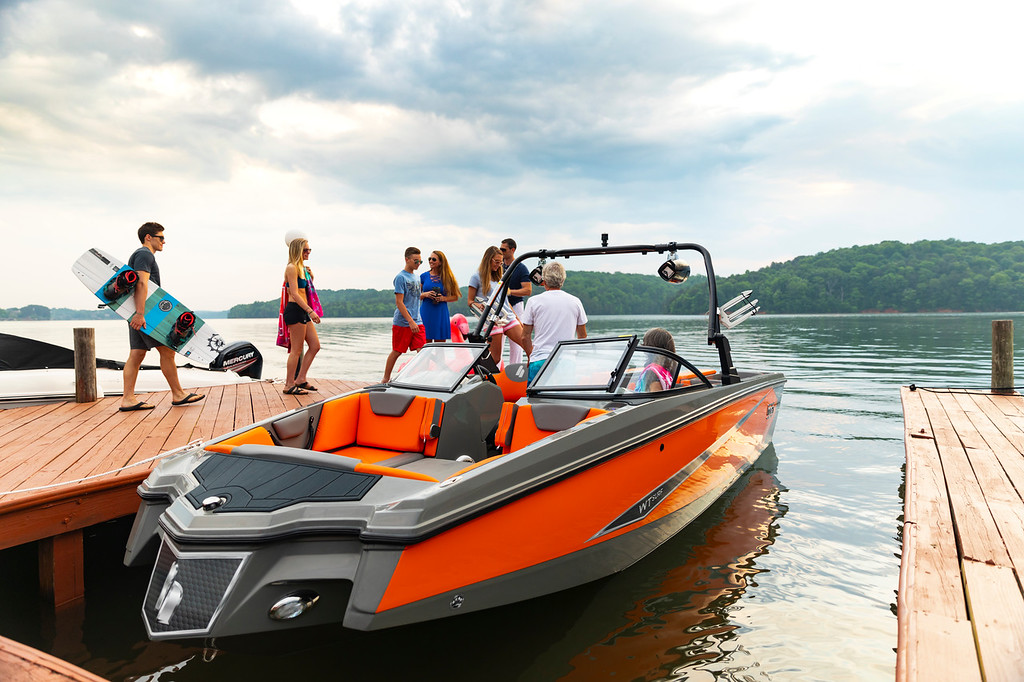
[0, 0, 1024, 309]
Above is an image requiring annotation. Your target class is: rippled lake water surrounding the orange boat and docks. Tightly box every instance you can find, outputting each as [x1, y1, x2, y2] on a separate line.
[0, 313, 1024, 682]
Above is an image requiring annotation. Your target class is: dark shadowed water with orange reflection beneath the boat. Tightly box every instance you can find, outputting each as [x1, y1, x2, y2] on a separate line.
[0, 447, 785, 682]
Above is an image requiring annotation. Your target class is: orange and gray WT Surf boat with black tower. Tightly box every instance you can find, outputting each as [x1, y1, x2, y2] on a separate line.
[125, 238, 785, 639]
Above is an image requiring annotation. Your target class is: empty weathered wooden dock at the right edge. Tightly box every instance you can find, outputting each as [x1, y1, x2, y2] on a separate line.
[896, 386, 1024, 682]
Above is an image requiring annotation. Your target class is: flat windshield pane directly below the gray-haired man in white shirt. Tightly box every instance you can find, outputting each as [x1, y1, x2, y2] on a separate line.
[530, 336, 636, 391]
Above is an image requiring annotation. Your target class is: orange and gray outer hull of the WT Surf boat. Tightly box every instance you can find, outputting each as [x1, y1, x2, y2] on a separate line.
[129, 368, 783, 639]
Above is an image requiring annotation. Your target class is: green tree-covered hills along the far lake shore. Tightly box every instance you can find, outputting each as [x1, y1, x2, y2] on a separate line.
[14, 240, 1024, 321]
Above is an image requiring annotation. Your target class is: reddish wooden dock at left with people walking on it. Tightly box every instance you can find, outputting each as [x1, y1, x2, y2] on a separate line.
[0, 379, 370, 606]
